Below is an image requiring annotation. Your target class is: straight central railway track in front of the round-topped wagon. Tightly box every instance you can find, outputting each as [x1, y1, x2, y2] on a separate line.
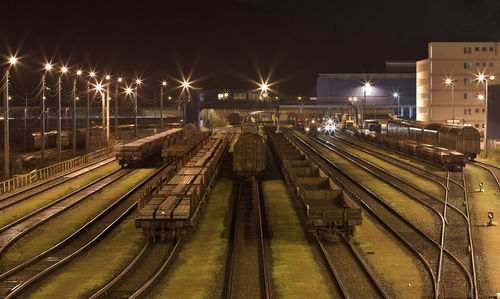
[225, 180, 271, 298]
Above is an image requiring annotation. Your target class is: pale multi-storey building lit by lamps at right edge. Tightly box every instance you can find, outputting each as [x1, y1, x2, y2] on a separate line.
[417, 42, 500, 133]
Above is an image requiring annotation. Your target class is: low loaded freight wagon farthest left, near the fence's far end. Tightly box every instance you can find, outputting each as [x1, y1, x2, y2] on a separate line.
[116, 128, 182, 167]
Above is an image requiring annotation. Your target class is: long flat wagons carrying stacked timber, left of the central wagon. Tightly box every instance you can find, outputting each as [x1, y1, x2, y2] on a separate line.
[136, 135, 229, 240]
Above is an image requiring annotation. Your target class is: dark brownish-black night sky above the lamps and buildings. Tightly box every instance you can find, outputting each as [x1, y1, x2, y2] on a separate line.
[0, 0, 500, 96]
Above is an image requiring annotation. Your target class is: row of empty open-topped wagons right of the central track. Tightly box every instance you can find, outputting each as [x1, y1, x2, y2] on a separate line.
[266, 128, 361, 238]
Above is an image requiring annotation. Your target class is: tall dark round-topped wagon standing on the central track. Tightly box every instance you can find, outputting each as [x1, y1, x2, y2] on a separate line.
[233, 121, 266, 178]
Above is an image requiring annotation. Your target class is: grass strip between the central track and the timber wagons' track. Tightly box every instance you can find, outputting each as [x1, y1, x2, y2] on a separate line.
[151, 179, 233, 298]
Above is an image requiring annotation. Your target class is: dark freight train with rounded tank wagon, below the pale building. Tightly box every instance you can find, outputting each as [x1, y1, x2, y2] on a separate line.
[351, 120, 480, 170]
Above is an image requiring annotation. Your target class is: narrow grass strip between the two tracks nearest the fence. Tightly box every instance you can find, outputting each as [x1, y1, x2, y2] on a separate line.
[0, 162, 120, 227]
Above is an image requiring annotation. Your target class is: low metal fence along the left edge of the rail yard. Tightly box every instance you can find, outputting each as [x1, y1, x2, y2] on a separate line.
[0, 146, 115, 194]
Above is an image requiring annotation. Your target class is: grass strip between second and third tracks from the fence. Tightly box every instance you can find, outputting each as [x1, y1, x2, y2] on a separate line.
[0, 168, 155, 270]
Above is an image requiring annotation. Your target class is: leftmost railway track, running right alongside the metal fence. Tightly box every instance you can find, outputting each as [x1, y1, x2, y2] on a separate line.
[0, 157, 115, 211]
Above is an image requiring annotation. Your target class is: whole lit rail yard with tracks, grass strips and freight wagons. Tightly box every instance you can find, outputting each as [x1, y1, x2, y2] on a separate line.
[0, 113, 500, 298]
